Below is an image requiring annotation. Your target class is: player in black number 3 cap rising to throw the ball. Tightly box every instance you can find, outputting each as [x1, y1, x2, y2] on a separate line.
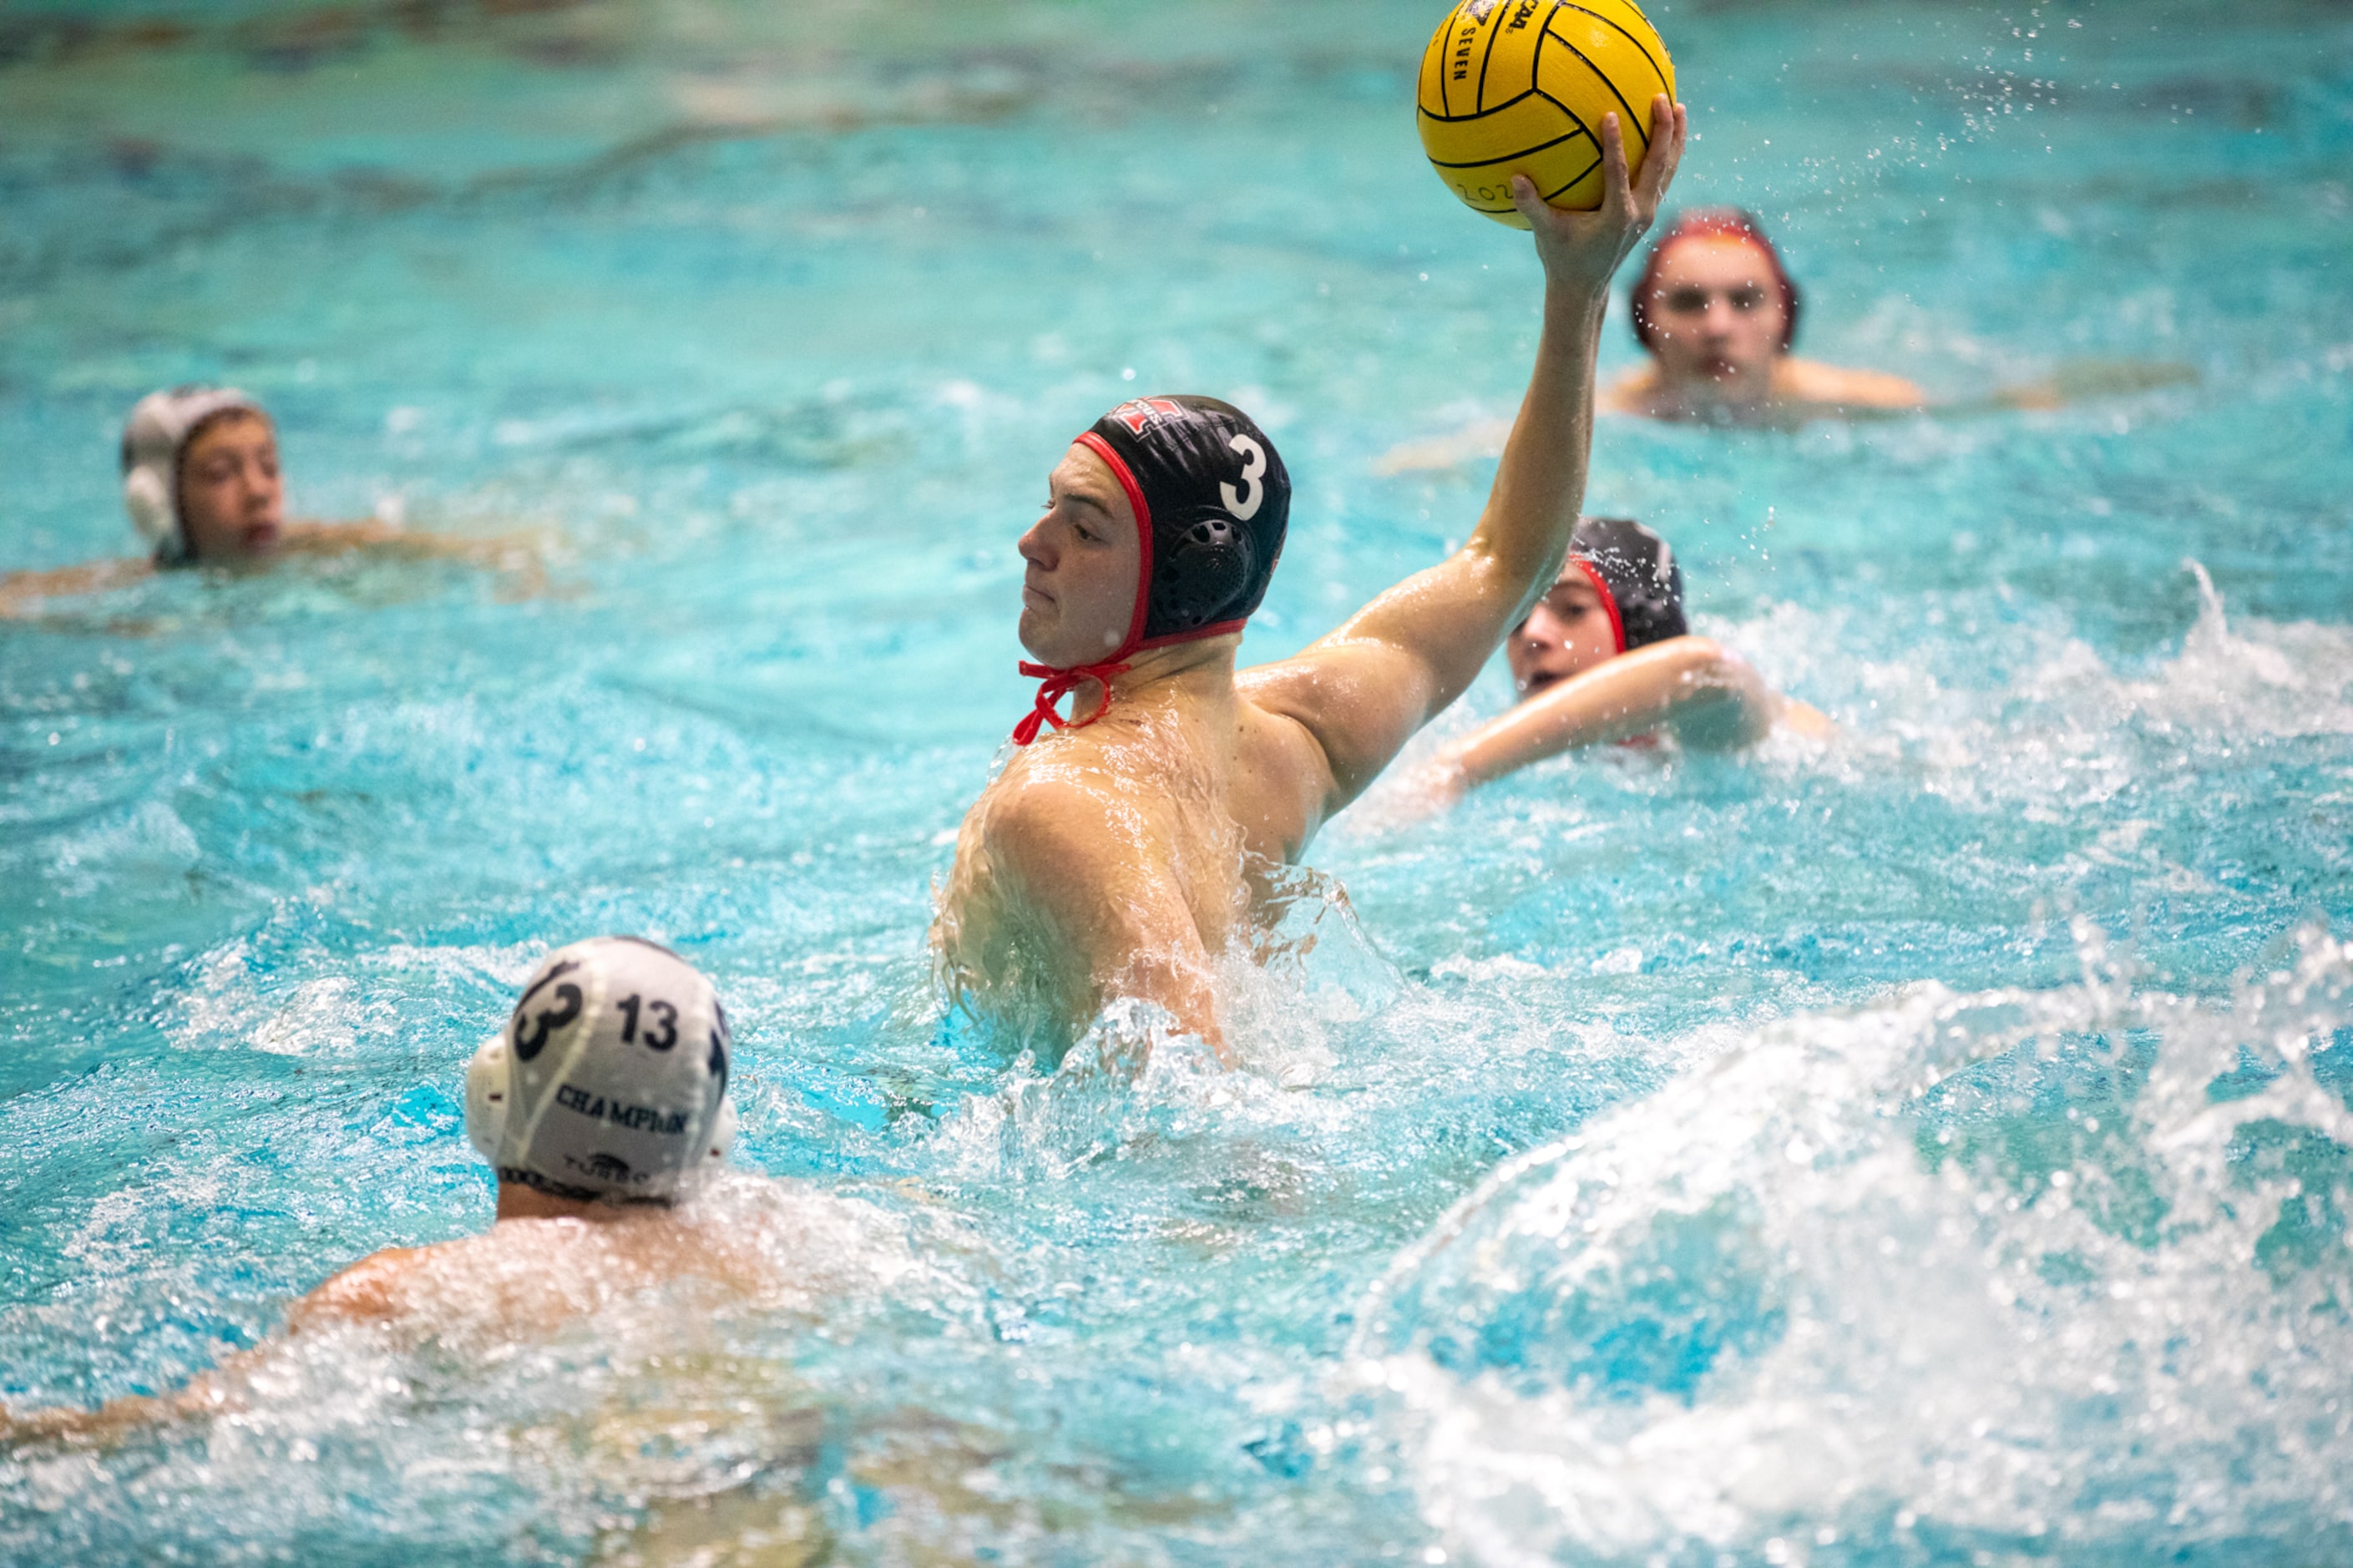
[934, 97, 1685, 1062]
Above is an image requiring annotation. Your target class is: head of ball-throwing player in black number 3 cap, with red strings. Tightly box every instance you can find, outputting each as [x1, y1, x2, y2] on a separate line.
[1015, 398, 1292, 746]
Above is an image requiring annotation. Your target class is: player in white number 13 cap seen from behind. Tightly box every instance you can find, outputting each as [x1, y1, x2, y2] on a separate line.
[0, 937, 757, 1441]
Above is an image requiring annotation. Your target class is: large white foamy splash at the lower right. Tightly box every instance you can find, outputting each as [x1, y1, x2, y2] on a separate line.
[1355, 933, 2353, 1563]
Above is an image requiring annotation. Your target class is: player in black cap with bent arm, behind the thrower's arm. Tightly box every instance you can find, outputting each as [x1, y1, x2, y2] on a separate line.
[1433, 518, 1830, 796]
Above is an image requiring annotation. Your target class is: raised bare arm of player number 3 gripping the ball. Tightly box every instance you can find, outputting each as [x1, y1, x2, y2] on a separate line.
[1242, 94, 1685, 810]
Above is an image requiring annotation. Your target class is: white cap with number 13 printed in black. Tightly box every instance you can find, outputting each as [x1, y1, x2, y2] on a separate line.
[466, 937, 734, 1203]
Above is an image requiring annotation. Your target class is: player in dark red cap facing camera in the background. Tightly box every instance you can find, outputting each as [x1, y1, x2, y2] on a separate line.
[1605, 207, 1927, 422]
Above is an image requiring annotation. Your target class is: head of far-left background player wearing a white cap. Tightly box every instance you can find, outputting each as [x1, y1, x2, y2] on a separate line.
[123, 386, 285, 565]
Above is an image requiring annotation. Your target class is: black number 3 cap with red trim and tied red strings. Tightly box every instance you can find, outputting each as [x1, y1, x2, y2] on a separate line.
[1015, 396, 1292, 746]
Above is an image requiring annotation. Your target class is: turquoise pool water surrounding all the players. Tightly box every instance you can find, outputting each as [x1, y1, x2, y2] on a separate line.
[0, 0, 2353, 1563]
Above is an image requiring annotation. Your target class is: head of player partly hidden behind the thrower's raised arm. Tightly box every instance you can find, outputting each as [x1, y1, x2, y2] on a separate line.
[1504, 518, 1689, 697]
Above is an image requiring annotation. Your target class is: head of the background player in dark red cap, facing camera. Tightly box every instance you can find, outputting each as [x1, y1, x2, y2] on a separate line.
[1631, 207, 1798, 402]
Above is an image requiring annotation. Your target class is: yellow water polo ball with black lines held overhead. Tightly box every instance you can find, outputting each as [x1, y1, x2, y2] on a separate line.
[1416, 0, 1675, 229]
